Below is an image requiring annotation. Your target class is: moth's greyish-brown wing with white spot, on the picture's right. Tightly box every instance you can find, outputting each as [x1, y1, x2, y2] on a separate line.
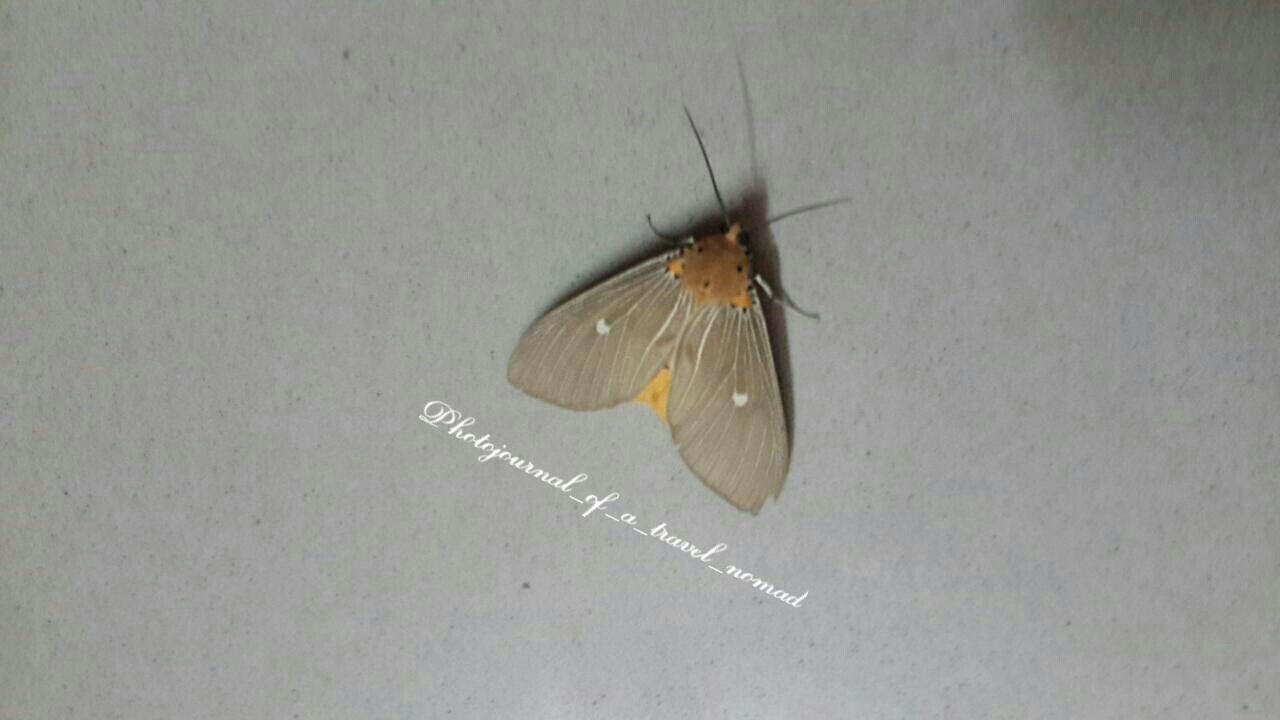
[667, 291, 788, 512]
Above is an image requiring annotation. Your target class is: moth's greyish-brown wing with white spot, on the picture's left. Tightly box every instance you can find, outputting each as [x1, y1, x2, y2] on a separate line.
[507, 254, 691, 410]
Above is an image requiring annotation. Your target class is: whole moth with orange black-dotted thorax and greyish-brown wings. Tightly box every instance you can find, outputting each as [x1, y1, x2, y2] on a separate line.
[507, 108, 847, 514]
